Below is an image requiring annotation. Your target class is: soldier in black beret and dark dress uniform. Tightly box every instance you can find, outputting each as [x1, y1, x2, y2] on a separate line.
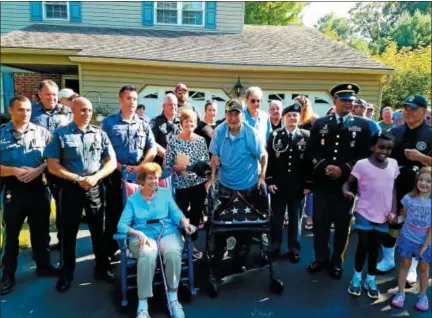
[266, 104, 309, 263]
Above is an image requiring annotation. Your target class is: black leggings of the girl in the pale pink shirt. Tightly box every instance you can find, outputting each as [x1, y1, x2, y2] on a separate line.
[355, 230, 384, 275]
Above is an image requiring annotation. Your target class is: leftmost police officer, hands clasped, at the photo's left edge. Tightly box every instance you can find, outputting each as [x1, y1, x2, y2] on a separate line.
[0, 96, 58, 295]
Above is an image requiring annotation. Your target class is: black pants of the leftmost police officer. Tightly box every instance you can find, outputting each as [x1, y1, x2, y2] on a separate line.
[3, 181, 50, 277]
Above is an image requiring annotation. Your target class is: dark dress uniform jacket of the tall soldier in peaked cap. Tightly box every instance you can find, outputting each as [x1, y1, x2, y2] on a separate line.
[305, 114, 375, 191]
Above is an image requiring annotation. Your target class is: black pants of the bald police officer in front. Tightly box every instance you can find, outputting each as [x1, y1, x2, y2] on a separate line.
[60, 182, 110, 277]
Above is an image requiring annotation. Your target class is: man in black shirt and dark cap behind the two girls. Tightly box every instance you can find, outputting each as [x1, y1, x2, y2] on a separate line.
[377, 94, 432, 283]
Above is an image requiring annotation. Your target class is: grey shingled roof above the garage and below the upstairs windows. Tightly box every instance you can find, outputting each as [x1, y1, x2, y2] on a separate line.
[1, 24, 392, 71]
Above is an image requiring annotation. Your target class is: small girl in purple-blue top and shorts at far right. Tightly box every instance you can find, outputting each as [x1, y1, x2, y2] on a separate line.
[392, 167, 432, 311]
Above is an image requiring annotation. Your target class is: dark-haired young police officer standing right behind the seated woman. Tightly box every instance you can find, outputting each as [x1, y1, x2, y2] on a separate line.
[101, 85, 156, 260]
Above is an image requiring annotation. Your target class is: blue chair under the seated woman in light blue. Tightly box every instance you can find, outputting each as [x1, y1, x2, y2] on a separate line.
[114, 171, 197, 308]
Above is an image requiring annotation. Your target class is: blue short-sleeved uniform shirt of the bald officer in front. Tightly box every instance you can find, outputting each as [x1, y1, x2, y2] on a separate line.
[45, 122, 116, 176]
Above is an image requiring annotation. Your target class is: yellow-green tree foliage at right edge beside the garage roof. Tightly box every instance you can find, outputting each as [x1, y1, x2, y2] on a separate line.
[373, 42, 432, 107]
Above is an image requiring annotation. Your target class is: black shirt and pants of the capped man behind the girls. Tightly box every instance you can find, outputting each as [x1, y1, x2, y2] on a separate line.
[390, 121, 432, 204]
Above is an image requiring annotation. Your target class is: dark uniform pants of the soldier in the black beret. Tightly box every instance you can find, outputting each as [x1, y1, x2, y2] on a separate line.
[271, 188, 302, 253]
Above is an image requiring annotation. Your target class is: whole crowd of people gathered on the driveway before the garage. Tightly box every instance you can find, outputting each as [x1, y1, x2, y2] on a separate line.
[0, 80, 432, 318]
